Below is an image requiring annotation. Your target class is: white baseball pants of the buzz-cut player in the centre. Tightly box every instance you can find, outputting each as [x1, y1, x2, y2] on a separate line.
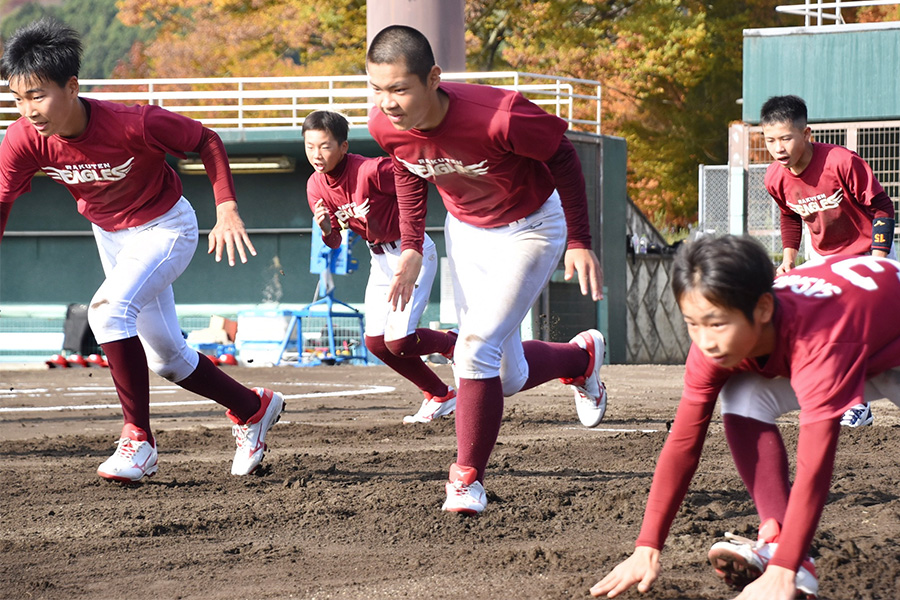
[445, 191, 566, 396]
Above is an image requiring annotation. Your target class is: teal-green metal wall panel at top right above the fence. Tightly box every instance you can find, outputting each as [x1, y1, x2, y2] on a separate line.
[742, 23, 900, 124]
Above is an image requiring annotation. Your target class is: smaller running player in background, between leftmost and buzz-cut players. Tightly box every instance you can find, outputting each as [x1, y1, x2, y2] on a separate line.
[303, 110, 456, 423]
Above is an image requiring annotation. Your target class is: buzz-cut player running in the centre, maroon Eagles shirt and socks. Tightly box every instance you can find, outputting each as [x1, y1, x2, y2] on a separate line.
[366, 25, 606, 513]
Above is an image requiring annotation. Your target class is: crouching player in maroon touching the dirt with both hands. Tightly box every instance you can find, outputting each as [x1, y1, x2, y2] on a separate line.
[591, 236, 900, 600]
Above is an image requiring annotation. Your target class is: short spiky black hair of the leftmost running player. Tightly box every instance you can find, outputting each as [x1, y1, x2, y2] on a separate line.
[0, 17, 82, 87]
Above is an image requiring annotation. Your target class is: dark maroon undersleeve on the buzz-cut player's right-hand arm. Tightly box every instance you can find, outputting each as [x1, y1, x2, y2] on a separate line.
[546, 136, 591, 249]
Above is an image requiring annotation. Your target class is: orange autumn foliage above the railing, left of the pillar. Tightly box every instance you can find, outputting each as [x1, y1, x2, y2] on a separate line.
[116, 0, 366, 77]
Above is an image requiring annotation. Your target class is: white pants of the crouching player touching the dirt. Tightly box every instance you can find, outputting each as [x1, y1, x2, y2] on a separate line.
[719, 368, 900, 424]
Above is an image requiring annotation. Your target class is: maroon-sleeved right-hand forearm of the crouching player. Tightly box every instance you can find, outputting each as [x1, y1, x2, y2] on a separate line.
[769, 420, 841, 571]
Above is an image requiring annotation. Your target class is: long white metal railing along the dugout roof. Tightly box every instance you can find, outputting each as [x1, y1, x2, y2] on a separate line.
[0, 71, 600, 134]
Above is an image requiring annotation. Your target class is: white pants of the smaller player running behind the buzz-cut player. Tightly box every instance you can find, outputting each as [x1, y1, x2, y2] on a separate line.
[365, 234, 438, 342]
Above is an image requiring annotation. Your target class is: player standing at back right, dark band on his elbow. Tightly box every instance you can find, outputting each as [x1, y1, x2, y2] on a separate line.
[760, 96, 897, 427]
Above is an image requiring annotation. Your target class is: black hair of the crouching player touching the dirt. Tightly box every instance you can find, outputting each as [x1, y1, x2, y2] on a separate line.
[672, 235, 775, 323]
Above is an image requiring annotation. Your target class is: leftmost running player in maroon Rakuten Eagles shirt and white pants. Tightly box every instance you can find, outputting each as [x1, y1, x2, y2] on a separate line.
[0, 20, 284, 481]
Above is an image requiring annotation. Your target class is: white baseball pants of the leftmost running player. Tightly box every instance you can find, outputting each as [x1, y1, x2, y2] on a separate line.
[88, 198, 198, 381]
